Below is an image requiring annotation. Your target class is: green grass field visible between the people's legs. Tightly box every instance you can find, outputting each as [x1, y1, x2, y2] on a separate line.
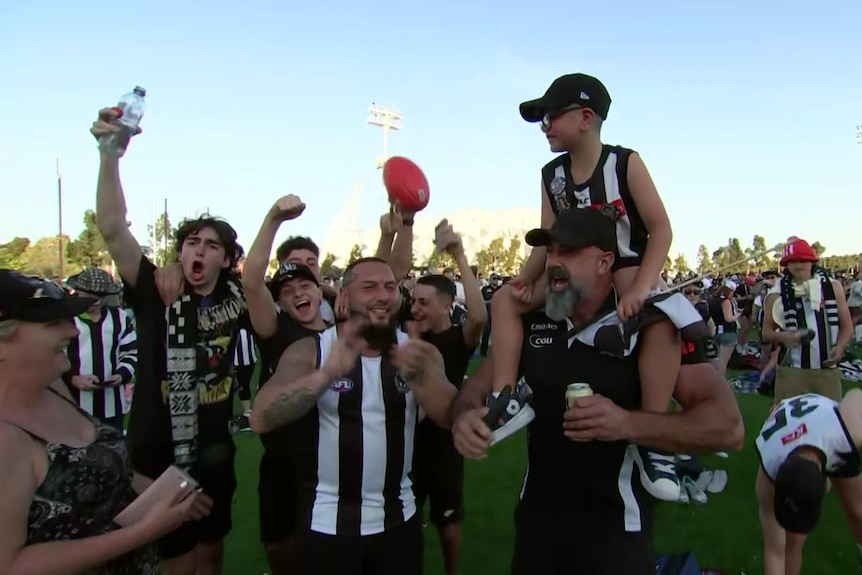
[225, 364, 862, 575]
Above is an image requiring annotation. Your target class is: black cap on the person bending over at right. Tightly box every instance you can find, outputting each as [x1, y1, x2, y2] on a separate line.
[773, 453, 826, 534]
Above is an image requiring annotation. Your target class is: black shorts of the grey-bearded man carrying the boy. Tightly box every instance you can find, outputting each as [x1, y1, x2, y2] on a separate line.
[511, 501, 655, 575]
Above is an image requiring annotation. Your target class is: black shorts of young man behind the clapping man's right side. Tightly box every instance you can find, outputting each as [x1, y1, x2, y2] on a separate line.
[413, 420, 464, 527]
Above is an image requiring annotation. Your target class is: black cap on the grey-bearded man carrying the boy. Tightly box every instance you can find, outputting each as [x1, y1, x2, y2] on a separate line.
[524, 208, 617, 252]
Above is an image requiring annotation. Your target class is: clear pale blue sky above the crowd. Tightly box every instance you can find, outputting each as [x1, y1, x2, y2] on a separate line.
[0, 0, 862, 262]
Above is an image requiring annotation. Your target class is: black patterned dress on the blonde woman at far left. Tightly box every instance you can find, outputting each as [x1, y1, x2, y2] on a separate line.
[27, 398, 158, 575]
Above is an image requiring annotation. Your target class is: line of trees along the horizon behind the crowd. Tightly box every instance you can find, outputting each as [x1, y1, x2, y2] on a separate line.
[0, 214, 862, 278]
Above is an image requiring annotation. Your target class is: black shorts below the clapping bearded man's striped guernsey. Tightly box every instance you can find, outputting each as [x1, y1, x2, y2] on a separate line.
[293, 513, 424, 575]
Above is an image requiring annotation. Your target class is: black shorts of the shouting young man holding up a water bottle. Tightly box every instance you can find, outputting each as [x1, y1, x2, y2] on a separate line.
[132, 441, 236, 559]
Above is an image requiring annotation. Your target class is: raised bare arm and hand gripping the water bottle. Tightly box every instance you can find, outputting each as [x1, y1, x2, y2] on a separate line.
[90, 108, 143, 287]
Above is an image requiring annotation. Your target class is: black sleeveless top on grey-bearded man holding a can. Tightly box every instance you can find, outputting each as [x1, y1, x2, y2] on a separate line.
[520, 301, 653, 528]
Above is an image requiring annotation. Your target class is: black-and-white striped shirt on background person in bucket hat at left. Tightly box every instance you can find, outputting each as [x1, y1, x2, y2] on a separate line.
[64, 307, 138, 419]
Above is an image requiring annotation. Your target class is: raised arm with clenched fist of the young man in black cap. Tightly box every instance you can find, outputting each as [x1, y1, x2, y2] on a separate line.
[242, 195, 305, 339]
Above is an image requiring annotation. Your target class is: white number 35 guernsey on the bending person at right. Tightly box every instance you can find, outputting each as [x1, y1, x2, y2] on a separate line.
[755, 393, 859, 481]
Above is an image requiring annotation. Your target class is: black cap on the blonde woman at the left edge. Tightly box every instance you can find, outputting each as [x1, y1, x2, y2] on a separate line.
[0, 269, 98, 323]
